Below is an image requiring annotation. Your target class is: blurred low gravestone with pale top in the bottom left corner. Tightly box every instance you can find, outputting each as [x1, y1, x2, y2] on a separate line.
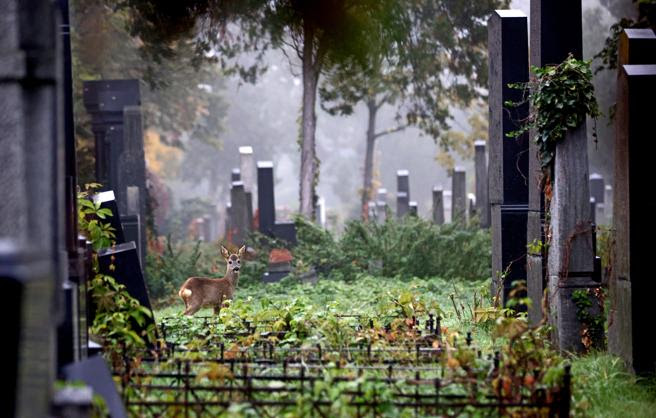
[0, 242, 55, 417]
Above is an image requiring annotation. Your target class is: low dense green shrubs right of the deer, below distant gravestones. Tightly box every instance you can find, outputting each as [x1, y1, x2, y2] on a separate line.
[294, 217, 491, 280]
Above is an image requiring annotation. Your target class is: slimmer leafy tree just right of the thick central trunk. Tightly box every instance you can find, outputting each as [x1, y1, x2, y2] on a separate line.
[319, 0, 508, 218]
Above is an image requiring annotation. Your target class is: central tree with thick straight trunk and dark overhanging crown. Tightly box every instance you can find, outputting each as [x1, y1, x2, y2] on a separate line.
[113, 0, 399, 217]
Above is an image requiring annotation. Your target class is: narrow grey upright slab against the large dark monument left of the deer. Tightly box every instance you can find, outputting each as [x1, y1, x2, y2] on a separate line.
[117, 106, 148, 264]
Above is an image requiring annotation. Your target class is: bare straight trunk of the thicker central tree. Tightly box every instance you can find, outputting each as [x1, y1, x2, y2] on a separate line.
[299, 24, 319, 219]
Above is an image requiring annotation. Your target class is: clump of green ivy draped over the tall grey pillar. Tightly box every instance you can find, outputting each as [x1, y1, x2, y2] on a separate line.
[505, 54, 600, 168]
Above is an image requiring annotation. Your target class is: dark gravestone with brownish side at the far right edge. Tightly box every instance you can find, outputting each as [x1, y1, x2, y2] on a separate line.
[608, 29, 656, 374]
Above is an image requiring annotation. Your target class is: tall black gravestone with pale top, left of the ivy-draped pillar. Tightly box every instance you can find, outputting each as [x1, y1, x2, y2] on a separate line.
[490, 10, 529, 304]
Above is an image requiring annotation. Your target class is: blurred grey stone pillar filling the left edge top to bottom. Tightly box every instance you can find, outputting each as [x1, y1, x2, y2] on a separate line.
[0, 0, 67, 417]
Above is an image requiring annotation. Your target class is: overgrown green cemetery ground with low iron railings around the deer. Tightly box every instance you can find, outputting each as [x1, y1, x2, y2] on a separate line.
[93, 218, 656, 417]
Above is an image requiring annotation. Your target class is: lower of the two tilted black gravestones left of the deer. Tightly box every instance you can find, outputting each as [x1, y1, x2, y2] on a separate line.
[96, 241, 155, 344]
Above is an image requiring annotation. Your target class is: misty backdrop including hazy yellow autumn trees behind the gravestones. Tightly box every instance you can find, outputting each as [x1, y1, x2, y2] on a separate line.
[74, 0, 635, 234]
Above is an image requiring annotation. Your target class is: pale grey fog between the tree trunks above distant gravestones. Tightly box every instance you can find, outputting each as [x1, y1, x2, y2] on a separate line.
[147, 0, 630, 235]
